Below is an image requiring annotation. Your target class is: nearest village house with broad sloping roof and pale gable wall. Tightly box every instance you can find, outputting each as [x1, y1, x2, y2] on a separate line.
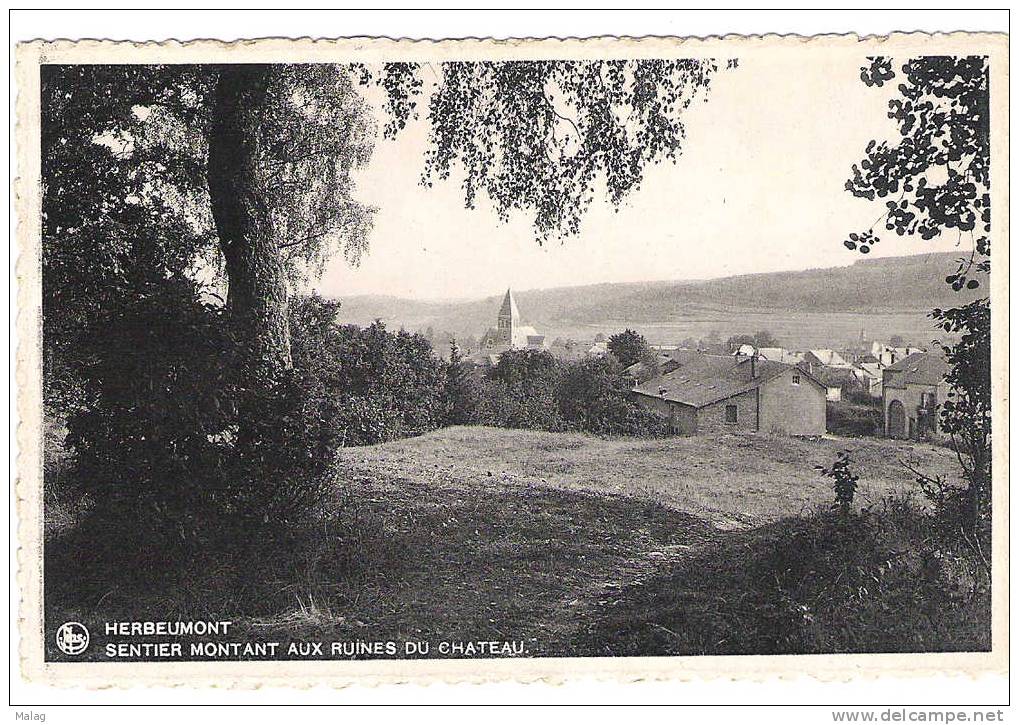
[633, 351, 825, 435]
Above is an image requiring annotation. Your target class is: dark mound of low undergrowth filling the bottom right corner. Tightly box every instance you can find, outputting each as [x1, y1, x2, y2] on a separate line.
[578, 498, 990, 657]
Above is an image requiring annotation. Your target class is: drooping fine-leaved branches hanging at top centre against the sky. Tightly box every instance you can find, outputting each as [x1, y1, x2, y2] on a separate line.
[356, 59, 736, 243]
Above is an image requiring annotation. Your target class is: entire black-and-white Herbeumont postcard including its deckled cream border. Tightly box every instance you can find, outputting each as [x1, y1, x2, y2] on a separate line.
[16, 34, 1009, 686]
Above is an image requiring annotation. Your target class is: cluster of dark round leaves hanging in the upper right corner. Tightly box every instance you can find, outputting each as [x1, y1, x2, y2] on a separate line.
[844, 56, 990, 290]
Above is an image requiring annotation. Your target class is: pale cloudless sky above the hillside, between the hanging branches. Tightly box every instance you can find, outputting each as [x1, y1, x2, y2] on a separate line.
[315, 52, 955, 299]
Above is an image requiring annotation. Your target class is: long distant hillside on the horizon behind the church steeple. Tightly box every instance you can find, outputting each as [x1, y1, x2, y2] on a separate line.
[332, 252, 983, 334]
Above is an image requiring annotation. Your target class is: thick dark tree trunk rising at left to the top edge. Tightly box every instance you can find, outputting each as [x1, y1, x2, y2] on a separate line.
[208, 64, 290, 379]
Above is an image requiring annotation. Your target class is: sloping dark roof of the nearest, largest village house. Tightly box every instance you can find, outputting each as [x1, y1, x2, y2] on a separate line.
[634, 353, 813, 408]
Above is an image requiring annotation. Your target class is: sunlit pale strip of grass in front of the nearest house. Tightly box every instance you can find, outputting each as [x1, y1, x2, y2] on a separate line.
[342, 426, 958, 529]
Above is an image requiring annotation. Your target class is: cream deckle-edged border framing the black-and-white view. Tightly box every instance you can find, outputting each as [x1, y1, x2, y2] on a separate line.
[15, 33, 1009, 688]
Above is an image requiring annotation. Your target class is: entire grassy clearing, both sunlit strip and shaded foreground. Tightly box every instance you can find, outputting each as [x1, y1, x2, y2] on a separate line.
[46, 427, 978, 658]
